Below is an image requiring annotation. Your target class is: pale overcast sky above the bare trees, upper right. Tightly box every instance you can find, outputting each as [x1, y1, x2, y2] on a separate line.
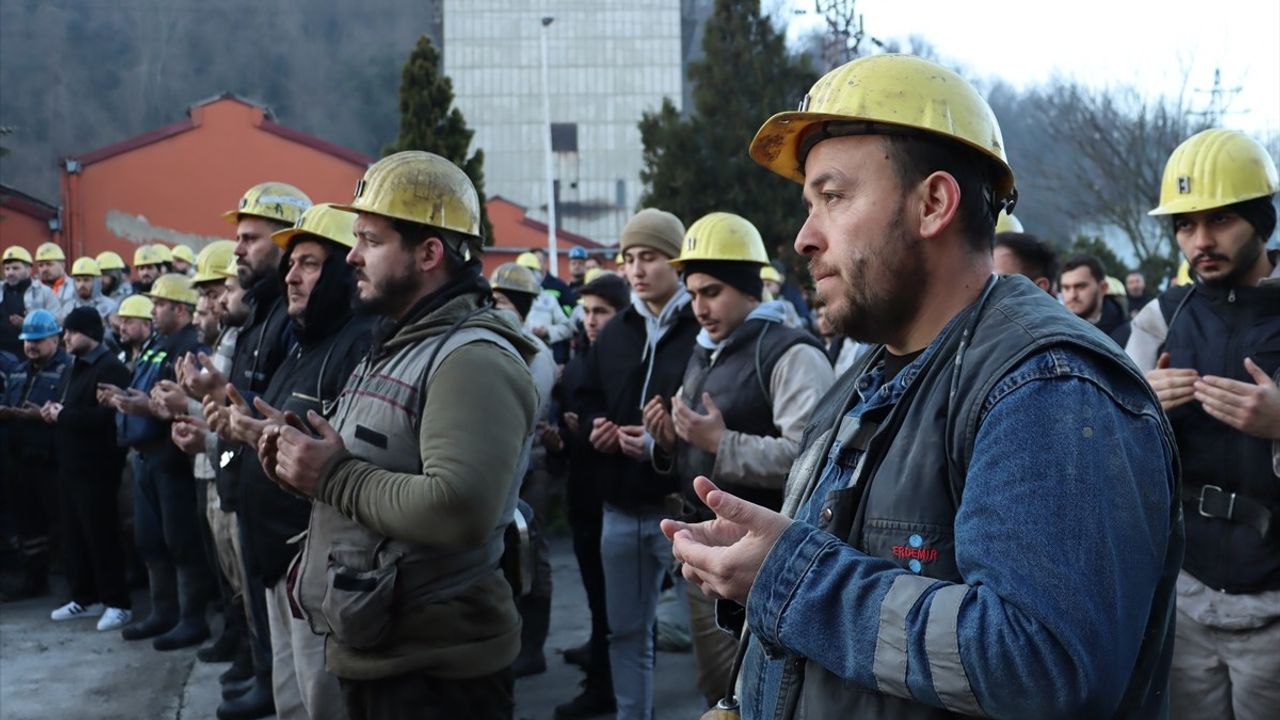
[765, 0, 1280, 136]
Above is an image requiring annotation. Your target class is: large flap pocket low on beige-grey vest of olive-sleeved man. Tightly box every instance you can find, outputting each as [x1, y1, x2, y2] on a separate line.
[320, 546, 399, 650]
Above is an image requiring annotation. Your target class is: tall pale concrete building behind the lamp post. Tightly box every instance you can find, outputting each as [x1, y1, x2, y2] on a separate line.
[443, 0, 705, 245]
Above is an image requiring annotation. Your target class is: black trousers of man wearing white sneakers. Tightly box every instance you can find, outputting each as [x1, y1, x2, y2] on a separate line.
[59, 474, 132, 610]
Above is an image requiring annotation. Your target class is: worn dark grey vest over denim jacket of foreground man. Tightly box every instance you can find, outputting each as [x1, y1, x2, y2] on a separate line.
[778, 275, 1183, 719]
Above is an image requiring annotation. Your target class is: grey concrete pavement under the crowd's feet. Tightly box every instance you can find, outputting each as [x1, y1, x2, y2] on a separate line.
[0, 538, 703, 720]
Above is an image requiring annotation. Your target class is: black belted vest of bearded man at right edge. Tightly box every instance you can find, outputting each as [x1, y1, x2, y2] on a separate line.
[1160, 278, 1280, 593]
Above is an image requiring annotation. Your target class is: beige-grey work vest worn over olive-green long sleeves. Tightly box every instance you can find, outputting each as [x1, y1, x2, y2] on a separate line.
[291, 322, 531, 650]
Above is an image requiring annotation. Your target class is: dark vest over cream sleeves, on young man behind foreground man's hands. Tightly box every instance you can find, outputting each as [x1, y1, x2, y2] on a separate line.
[676, 319, 822, 512]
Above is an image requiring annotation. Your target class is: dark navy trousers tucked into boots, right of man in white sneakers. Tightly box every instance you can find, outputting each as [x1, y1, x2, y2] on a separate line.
[133, 451, 207, 566]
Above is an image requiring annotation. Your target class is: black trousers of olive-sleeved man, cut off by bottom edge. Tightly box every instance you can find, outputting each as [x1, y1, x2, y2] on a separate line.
[339, 667, 516, 720]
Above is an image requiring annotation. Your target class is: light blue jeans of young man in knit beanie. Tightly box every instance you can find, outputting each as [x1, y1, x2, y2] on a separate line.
[600, 505, 672, 720]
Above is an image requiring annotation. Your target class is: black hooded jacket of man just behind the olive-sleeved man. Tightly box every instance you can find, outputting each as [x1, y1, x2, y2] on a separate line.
[238, 238, 372, 587]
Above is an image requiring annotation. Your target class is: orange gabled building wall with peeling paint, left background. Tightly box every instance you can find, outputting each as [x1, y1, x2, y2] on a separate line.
[61, 96, 371, 259]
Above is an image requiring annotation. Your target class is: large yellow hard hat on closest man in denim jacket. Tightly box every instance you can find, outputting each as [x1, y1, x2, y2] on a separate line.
[751, 54, 1018, 209]
